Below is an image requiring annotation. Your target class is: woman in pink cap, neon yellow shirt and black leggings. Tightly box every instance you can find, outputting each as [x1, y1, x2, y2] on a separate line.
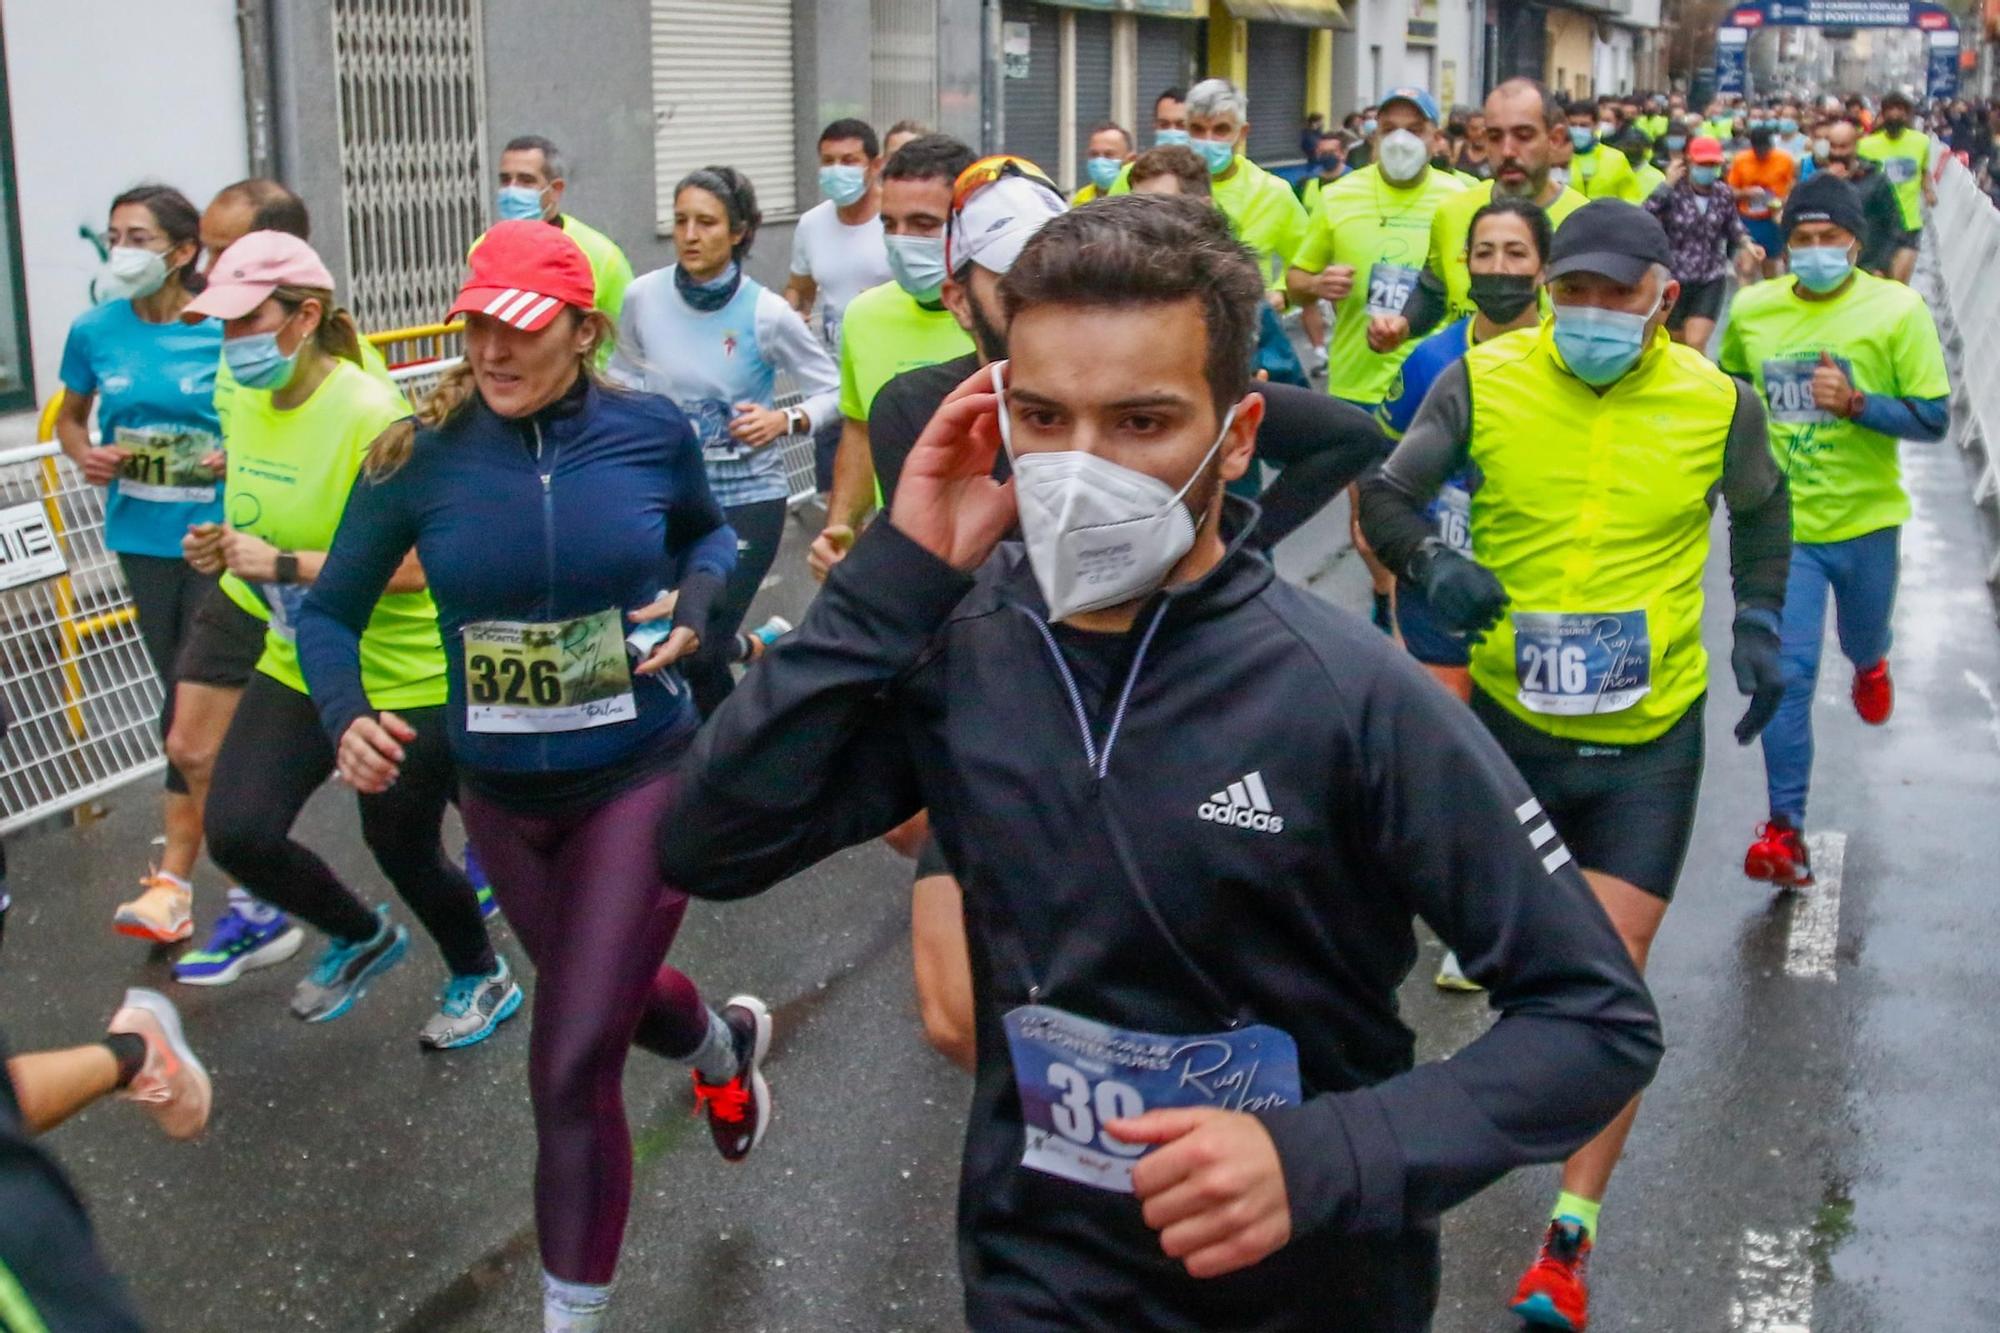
[182, 232, 508, 1049]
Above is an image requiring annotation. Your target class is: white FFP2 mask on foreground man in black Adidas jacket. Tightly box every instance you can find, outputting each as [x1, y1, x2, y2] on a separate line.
[992, 362, 1236, 620]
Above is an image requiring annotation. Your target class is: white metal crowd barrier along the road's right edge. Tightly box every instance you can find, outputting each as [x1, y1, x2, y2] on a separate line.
[1924, 138, 2000, 582]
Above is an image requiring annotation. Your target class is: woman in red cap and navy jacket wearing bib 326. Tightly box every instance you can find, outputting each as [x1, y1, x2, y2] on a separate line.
[298, 222, 770, 1329]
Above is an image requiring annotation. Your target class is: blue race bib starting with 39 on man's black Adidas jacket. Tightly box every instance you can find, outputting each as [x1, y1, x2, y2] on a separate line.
[1006, 1005, 1302, 1195]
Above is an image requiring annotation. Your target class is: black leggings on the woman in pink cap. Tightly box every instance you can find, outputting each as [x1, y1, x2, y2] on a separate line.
[204, 673, 494, 977]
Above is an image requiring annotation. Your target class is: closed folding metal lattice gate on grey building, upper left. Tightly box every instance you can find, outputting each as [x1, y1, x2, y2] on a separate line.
[332, 0, 488, 330]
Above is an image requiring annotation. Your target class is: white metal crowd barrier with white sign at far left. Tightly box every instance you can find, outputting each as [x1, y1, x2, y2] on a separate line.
[0, 444, 166, 833]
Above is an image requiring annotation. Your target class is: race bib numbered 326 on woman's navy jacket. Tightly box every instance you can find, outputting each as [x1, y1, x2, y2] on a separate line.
[464, 610, 638, 735]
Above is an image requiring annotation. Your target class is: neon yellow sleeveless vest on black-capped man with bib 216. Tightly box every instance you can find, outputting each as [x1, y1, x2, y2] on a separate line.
[1466, 320, 1736, 745]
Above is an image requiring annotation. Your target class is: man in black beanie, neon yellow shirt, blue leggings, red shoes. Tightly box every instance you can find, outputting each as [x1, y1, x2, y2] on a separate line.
[1718, 172, 1952, 887]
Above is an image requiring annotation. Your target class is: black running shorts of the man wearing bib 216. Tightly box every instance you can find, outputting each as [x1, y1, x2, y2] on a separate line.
[1472, 689, 1706, 901]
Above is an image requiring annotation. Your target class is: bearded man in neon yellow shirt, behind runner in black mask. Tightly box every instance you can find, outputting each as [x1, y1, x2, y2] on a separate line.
[1368, 78, 1588, 352]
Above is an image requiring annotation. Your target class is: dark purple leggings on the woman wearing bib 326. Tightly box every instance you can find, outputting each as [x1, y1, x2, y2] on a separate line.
[460, 773, 708, 1285]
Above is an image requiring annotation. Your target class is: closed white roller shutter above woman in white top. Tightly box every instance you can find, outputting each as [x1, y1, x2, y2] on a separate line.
[652, 0, 798, 236]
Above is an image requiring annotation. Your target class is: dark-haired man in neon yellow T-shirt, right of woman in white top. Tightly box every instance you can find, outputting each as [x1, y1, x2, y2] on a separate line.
[806, 134, 972, 578]
